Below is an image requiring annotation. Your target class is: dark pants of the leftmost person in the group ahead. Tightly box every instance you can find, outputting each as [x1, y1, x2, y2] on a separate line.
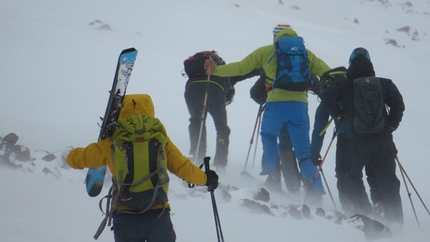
[184, 82, 230, 167]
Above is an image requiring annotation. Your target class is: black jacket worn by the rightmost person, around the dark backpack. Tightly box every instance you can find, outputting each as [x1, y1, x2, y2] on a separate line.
[321, 56, 405, 135]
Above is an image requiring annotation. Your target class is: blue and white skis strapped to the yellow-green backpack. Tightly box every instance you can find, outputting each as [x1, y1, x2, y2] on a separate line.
[85, 48, 137, 197]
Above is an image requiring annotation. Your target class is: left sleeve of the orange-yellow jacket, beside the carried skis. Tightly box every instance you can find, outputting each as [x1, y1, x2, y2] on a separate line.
[66, 138, 112, 169]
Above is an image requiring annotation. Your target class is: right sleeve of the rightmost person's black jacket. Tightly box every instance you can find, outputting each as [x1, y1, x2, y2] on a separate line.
[385, 80, 405, 129]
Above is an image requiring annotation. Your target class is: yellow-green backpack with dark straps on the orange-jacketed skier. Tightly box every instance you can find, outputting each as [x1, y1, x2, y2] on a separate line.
[112, 115, 169, 212]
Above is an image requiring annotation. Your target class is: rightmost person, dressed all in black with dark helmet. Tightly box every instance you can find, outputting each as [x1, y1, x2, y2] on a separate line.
[322, 47, 405, 224]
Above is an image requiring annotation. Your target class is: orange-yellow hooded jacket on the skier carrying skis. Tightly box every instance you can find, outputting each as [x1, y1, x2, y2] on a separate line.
[67, 94, 207, 209]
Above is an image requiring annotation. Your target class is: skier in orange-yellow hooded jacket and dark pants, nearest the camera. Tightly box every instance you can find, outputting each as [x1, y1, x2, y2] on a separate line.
[67, 94, 218, 242]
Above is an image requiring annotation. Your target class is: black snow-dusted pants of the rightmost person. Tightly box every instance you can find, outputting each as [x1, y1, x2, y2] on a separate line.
[344, 133, 403, 224]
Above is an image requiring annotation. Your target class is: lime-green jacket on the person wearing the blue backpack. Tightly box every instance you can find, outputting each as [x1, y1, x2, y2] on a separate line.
[213, 29, 330, 103]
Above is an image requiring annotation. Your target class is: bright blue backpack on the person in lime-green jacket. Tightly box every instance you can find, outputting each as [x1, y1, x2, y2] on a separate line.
[268, 36, 313, 91]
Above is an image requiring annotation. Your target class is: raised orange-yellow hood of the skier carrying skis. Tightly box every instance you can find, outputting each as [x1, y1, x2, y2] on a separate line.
[119, 94, 155, 119]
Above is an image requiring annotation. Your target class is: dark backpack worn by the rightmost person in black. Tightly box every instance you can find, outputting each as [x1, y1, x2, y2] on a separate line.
[353, 77, 385, 134]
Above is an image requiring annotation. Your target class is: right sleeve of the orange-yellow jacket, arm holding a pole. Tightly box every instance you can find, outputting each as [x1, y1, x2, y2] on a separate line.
[166, 140, 207, 186]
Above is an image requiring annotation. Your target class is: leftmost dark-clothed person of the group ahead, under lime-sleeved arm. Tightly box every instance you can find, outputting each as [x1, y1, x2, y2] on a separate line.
[184, 51, 256, 171]
